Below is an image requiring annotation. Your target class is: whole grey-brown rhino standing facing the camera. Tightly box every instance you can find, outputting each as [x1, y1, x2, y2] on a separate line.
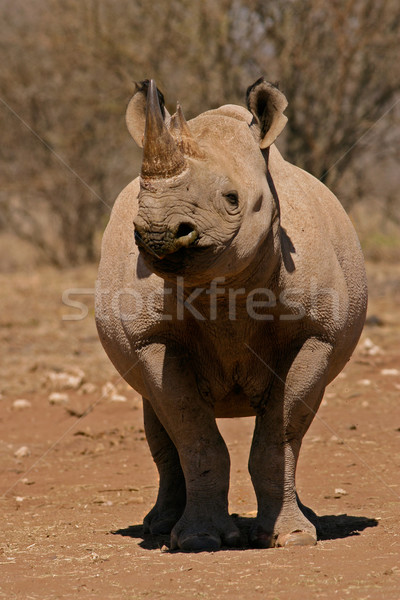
[96, 78, 367, 552]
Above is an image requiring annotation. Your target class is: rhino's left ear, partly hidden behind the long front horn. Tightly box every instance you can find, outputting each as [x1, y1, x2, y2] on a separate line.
[125, 79, 171, 148]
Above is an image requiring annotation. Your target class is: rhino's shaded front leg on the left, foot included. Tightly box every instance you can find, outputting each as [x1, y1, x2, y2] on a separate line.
[143, 345, 240, 552]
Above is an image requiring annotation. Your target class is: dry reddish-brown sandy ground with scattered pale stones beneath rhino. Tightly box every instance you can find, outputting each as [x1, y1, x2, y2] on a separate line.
[0, 265, 400, 600]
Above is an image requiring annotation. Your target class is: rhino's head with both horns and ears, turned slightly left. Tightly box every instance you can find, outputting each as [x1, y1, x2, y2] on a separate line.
[126, 79, 287, 284]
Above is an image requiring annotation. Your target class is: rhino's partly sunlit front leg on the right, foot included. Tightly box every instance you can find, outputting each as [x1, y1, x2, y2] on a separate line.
[249, 338, 332, 547]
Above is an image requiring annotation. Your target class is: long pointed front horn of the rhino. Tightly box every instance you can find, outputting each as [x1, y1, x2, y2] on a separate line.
[141, 79, 186, 179]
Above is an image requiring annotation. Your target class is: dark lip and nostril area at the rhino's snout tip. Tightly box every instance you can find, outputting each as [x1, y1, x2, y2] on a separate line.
[134, 220, 199, 258]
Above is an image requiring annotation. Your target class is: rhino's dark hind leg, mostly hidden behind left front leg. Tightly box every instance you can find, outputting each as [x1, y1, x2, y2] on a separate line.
[143, 398, 186, 534]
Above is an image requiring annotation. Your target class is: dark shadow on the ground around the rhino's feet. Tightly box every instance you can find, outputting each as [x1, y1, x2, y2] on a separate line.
[111, 514, 379, 550]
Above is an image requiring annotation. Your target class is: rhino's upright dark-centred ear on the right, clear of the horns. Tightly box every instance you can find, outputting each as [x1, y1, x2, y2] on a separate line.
[246, 77, 288, 148]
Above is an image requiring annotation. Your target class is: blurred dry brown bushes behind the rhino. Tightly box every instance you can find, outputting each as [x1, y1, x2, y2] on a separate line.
[0, 0, 400, 265]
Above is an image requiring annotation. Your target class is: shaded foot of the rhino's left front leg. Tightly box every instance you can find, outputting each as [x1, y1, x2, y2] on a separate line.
[171, 517, 241, 552]
